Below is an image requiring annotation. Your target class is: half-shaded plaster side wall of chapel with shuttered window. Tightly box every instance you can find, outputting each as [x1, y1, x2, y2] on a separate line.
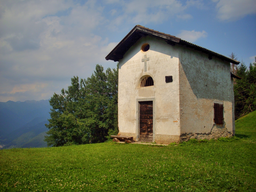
[177, 46, 234, 133]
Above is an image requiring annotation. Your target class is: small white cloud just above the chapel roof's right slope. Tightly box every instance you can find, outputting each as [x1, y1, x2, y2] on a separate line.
[177, 30, 207, 43]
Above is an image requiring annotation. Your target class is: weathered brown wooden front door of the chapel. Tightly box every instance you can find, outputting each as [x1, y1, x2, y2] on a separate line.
[139, 101, 153, 142]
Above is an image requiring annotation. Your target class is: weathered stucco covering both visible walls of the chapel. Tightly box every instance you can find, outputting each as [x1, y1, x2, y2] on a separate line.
[118, 36, 234, 143]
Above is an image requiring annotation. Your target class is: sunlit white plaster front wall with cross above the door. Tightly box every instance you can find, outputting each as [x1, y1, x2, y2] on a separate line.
[118, 37, 180, 141]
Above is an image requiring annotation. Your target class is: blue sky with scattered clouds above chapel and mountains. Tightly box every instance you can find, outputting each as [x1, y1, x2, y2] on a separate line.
[0, 0, 256, 102]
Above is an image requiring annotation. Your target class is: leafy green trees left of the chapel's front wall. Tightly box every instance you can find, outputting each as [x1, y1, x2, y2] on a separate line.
[45, 65, 118, 146]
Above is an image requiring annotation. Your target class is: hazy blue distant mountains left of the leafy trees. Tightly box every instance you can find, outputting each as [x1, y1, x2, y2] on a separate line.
[0, 100, 50, 148]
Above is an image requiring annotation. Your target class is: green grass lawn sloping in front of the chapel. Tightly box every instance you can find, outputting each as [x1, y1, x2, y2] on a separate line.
[0, 111, 256, 191]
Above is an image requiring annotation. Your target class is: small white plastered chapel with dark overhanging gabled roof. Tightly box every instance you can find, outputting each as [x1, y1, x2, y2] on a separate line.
[106, 25, 239, 144]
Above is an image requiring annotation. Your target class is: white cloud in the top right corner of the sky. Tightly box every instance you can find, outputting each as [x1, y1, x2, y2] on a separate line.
[213, 0, 256, 21]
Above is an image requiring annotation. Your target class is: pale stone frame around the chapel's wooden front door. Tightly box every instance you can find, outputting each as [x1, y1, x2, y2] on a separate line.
[135, 98, 156, 142]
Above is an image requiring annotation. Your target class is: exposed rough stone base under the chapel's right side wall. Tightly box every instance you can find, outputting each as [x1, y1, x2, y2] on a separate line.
[180, 126, 232, 142]
